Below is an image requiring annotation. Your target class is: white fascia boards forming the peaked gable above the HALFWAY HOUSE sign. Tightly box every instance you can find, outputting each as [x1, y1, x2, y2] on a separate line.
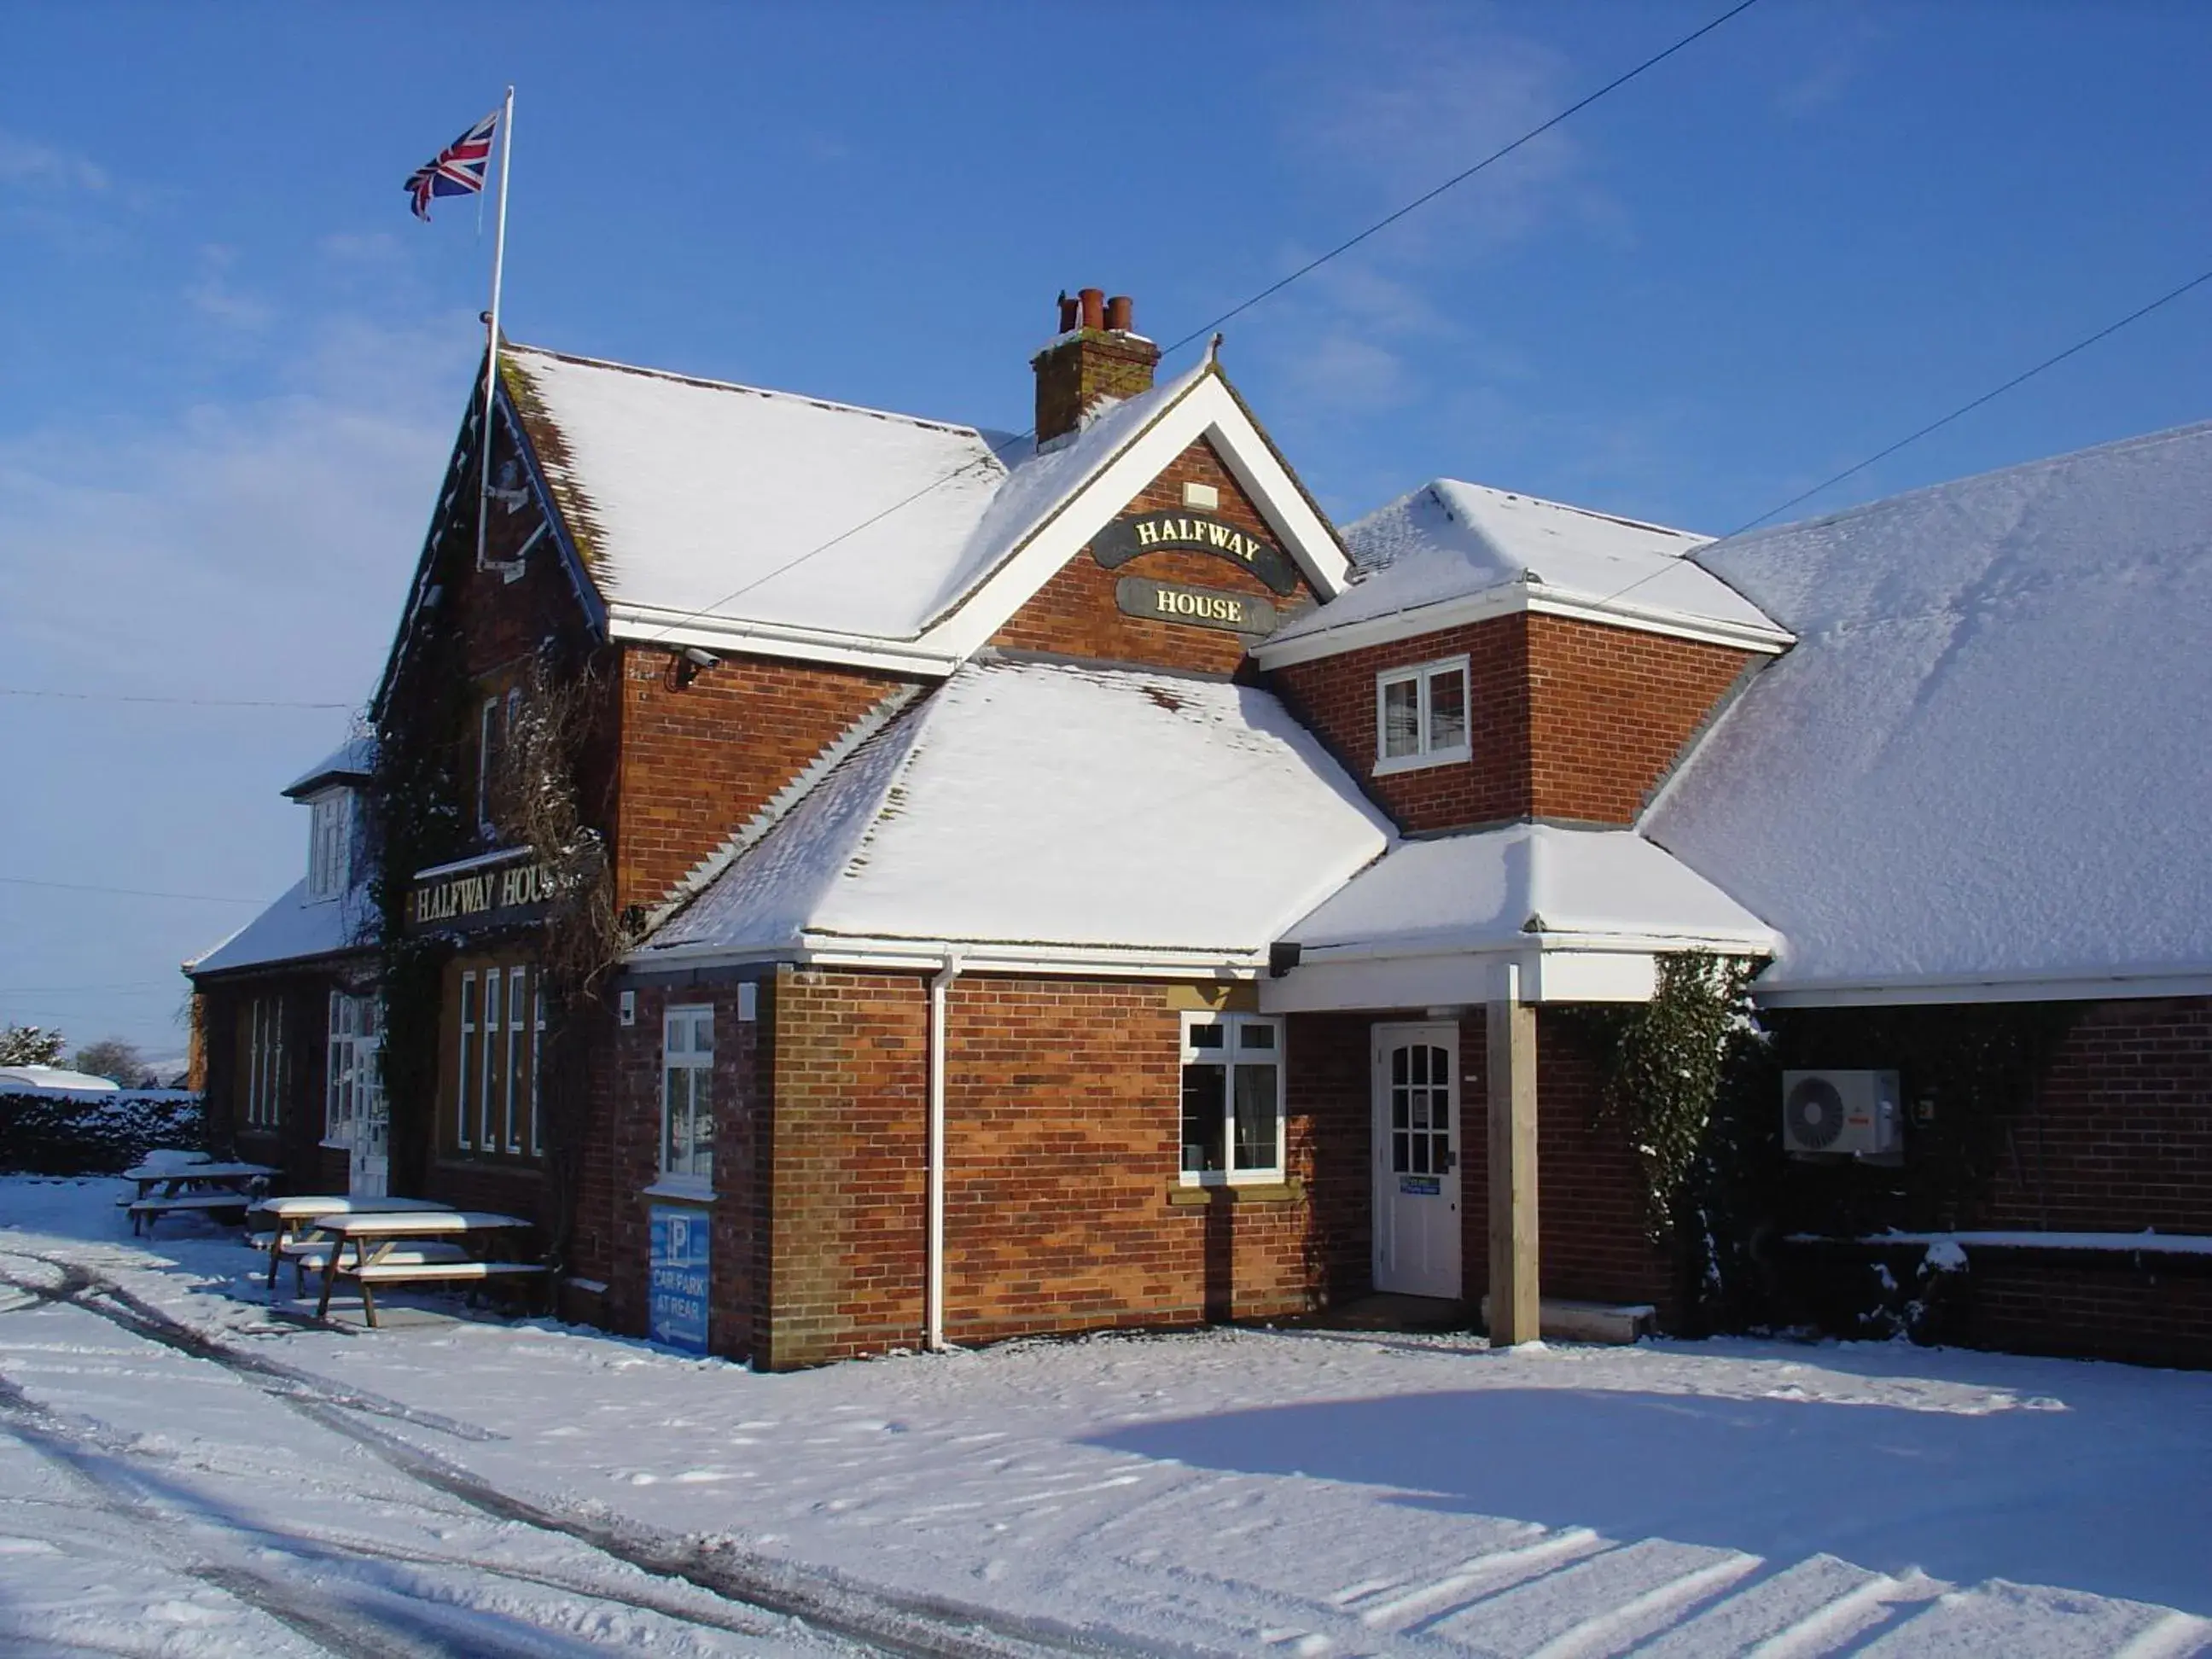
[918, 374, 1349, 661]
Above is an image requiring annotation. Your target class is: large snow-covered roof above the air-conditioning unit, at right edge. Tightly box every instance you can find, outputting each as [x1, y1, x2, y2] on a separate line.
[1641, 425, 2212, 1000]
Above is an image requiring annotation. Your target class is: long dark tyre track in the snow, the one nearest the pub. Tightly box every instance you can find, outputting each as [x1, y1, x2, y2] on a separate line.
[0, 1249, 1188, 1659]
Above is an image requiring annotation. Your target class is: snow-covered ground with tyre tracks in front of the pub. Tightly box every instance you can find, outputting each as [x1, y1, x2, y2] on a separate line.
[0, 1179, 2212, 1659]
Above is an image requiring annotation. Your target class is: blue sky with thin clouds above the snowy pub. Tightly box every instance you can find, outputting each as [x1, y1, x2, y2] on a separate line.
[0, 0, 2212, 1051]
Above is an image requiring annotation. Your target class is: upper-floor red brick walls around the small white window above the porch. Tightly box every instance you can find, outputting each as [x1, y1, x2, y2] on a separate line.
[1270, 613, 1749, 832]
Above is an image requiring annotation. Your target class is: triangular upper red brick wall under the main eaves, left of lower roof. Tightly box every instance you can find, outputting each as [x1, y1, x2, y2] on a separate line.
[615, 646, 909, 905]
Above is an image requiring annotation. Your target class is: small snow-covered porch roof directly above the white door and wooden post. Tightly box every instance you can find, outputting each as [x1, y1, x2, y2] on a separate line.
[1285, 823, 1774, 960]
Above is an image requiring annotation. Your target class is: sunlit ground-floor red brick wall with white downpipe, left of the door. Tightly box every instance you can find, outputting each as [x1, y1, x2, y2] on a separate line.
[754, 971, 1365, 1367]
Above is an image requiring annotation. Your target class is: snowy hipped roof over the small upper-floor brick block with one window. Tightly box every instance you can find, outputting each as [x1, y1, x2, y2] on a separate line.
[1263, 478, 1787, 657]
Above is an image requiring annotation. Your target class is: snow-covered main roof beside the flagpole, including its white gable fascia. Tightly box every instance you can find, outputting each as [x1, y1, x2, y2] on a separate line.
[500, 345, 1345, 672]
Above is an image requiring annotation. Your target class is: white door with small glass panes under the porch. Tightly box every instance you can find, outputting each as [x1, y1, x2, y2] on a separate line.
[1374, 1024, 1462, 1299]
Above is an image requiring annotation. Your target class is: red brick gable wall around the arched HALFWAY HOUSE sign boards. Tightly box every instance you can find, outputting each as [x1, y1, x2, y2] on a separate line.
[991, 438, 1314, 675]
